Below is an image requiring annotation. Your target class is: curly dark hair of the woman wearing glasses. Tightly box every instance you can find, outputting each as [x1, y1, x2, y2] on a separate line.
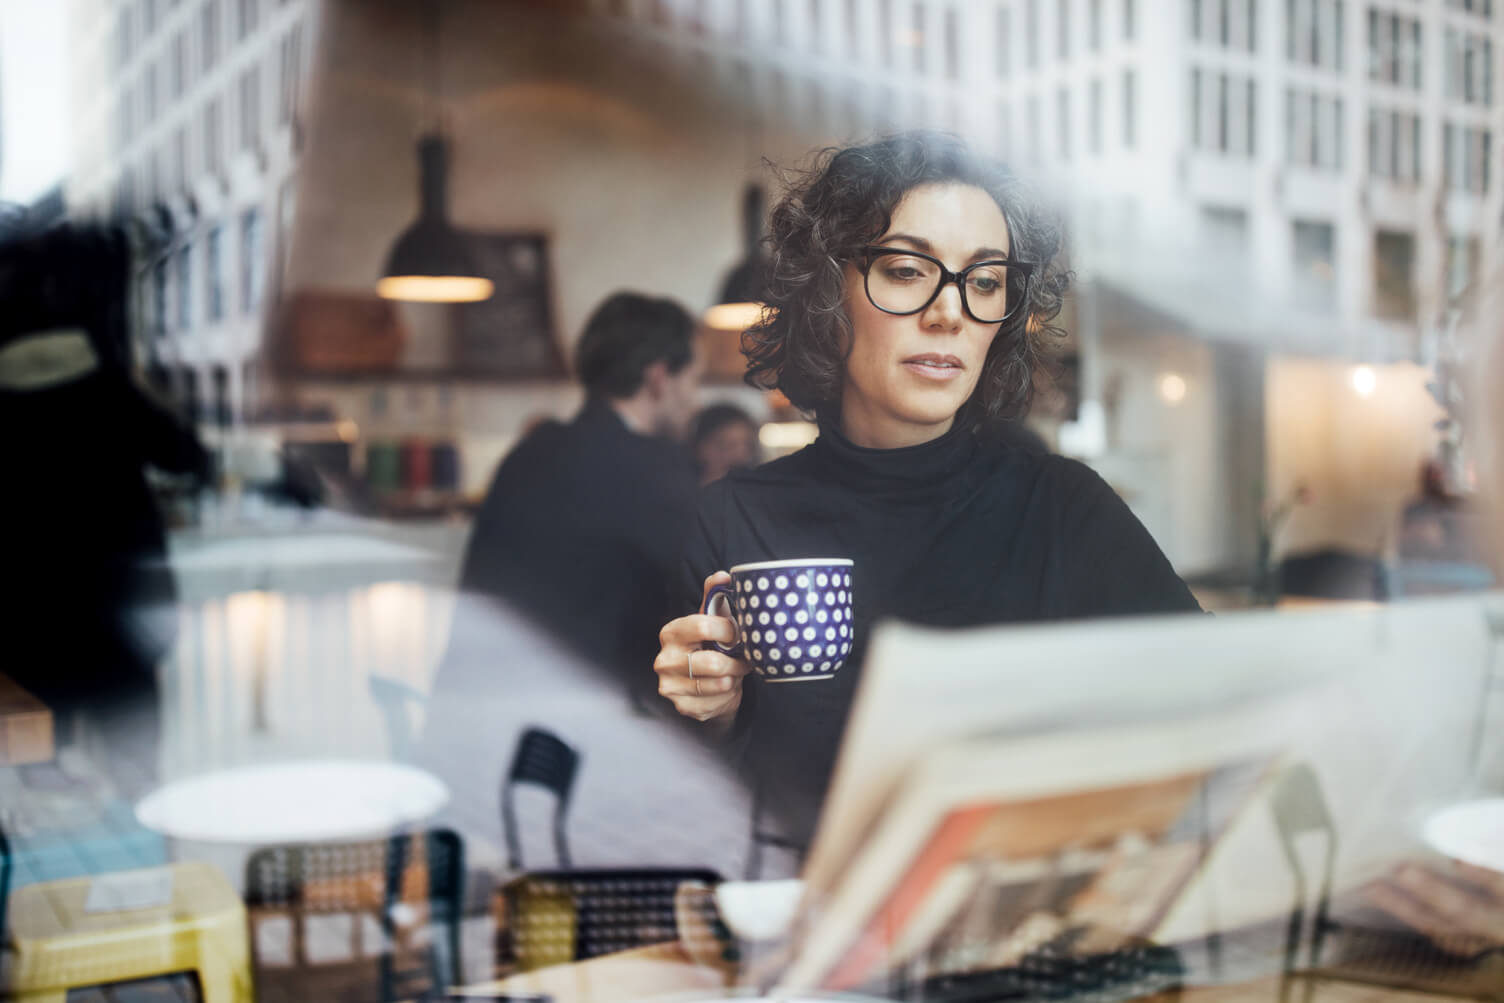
[741, 132, 1071, 421]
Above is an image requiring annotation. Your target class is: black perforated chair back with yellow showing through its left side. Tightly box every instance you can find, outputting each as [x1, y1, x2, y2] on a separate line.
[496, 868, 731, 973]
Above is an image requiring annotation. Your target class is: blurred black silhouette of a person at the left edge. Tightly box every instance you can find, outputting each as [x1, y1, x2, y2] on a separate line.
[0, 226, 211, 797]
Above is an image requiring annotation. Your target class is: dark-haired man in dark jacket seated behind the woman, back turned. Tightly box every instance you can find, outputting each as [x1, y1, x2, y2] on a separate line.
[451, 292, 702, 699]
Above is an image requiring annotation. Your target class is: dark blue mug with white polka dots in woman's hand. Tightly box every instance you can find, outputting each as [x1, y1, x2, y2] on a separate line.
[699, 558, 853, 683]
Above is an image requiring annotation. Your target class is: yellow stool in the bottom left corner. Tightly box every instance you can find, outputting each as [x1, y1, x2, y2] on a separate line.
[8, 862, 253, 1003]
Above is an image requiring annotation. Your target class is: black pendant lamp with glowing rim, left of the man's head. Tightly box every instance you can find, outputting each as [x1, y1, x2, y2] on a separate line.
[376, 3, 493, 302]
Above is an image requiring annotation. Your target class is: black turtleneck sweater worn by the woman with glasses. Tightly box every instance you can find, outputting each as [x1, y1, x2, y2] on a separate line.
[683, 426, 1200, 842]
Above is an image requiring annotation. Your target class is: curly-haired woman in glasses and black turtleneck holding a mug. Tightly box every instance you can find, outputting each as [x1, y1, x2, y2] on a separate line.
[654, 134, 1199, 842]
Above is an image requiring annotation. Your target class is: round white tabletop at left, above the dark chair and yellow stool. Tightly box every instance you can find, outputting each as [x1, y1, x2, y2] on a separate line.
[135, 759, 450, 845]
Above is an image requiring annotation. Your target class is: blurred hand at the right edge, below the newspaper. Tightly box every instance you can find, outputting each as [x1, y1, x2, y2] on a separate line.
[1367, 862, 1504, 956]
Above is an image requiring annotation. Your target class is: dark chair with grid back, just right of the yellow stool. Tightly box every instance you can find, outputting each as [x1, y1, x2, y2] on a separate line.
[245, 829, 465, 1001]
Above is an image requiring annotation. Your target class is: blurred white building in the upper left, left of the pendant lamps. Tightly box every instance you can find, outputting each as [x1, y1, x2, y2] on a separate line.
[68, 0, 319, 424]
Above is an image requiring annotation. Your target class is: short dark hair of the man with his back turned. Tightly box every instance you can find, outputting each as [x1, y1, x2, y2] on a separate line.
[575, 293, 695, 400]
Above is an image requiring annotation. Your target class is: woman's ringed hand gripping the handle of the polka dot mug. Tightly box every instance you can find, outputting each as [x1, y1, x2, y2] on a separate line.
[653, 571, 752, 728]
